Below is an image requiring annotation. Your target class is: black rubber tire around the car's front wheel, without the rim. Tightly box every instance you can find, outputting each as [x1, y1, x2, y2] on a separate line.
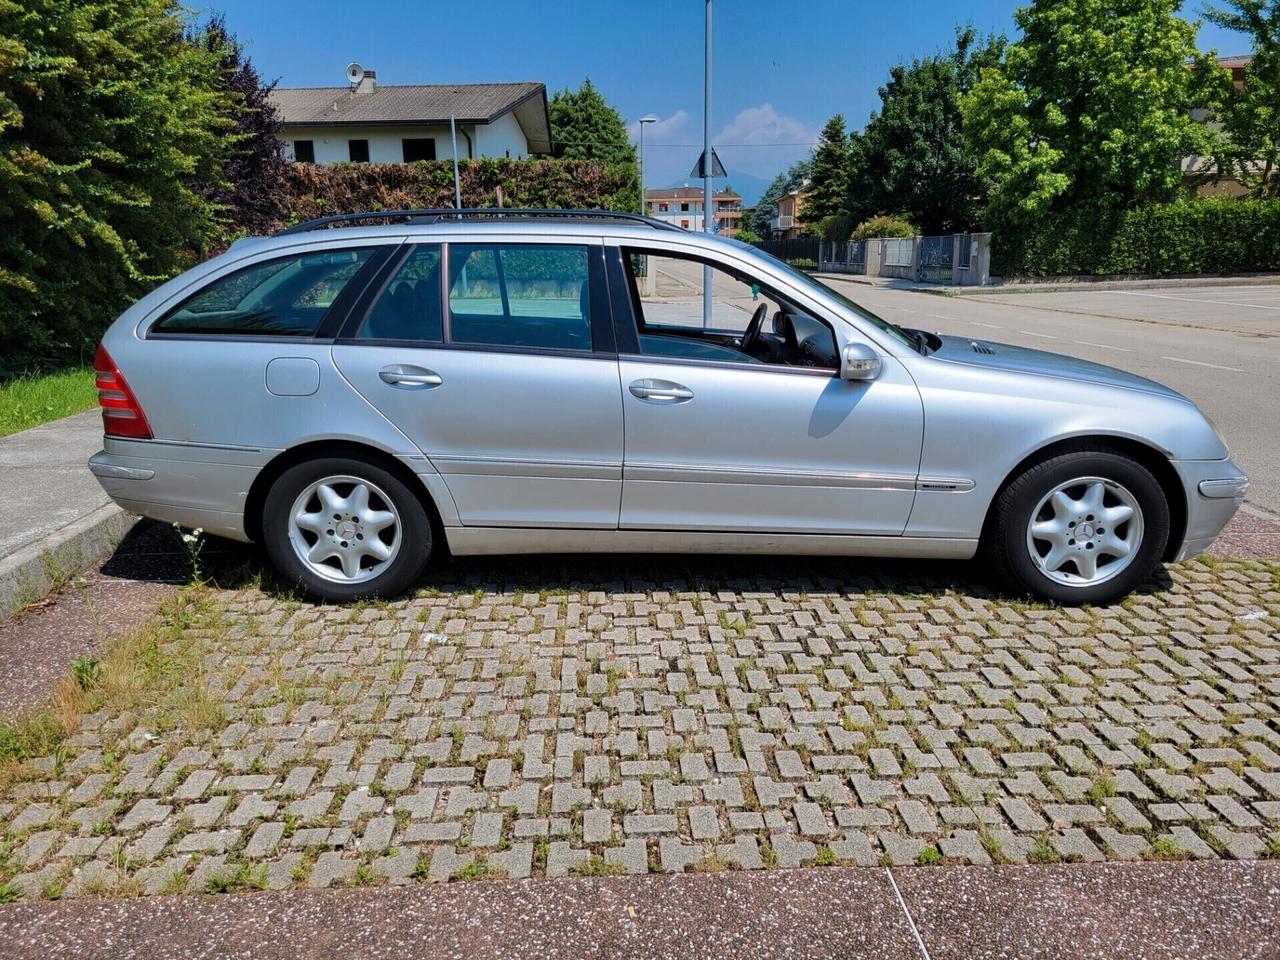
[983, 451, 1170, 604]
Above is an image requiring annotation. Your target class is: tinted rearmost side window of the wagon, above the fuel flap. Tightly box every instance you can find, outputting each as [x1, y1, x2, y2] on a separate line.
[151, 247, 375, 337]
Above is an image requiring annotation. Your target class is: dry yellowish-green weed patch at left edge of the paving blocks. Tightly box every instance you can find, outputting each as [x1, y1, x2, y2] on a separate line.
[0, 590, 227, 786]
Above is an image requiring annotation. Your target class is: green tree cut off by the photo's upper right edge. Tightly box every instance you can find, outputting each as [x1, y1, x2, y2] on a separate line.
[1204, 0, 1280, 197]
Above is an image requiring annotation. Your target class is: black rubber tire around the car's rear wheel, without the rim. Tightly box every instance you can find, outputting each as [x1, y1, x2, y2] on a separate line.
[262, 457, 433, 603]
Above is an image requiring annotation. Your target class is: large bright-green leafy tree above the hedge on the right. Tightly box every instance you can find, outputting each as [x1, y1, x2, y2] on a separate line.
[960, 0, 1212, 227]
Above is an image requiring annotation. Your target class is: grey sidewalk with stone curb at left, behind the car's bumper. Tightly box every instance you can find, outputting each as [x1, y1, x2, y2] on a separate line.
[0, 410, 133, 621]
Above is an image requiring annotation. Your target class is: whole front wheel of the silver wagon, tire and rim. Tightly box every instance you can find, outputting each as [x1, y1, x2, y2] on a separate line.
[987, 451, 1170, 604]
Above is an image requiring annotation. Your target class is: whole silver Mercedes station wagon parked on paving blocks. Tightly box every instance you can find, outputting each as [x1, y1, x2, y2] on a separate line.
[90, 210, 1247, 603]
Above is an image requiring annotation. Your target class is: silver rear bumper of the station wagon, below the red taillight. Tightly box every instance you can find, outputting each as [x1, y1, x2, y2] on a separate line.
[88, 438, 270, 540]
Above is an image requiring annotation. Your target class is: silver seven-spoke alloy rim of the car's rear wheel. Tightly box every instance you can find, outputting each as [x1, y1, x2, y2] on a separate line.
[289, 475, 402, 584]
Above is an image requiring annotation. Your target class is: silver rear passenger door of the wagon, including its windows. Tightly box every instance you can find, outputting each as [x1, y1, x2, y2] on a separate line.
[333, 242, 622, 529]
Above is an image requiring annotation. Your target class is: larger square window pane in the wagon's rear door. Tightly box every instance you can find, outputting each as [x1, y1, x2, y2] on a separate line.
[449, 243, 591, 351]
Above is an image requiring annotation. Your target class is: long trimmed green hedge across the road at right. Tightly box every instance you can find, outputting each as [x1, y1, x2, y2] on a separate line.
[991, 197, 1280, 276]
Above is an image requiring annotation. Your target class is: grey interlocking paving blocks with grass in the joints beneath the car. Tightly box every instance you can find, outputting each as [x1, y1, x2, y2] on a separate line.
[0, 558, 1280, 896]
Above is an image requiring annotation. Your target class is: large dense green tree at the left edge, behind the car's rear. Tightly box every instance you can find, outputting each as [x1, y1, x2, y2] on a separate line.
[0, 0, 233, 369]
